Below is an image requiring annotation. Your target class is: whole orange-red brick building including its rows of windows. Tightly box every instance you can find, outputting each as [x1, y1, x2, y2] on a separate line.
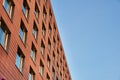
[0, 0, 72, 80]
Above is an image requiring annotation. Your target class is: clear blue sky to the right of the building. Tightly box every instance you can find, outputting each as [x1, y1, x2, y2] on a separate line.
[51, 0, 120, 80]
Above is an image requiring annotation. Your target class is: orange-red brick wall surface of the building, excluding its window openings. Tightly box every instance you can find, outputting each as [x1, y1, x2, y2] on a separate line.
[0, 0, 72, 80]
